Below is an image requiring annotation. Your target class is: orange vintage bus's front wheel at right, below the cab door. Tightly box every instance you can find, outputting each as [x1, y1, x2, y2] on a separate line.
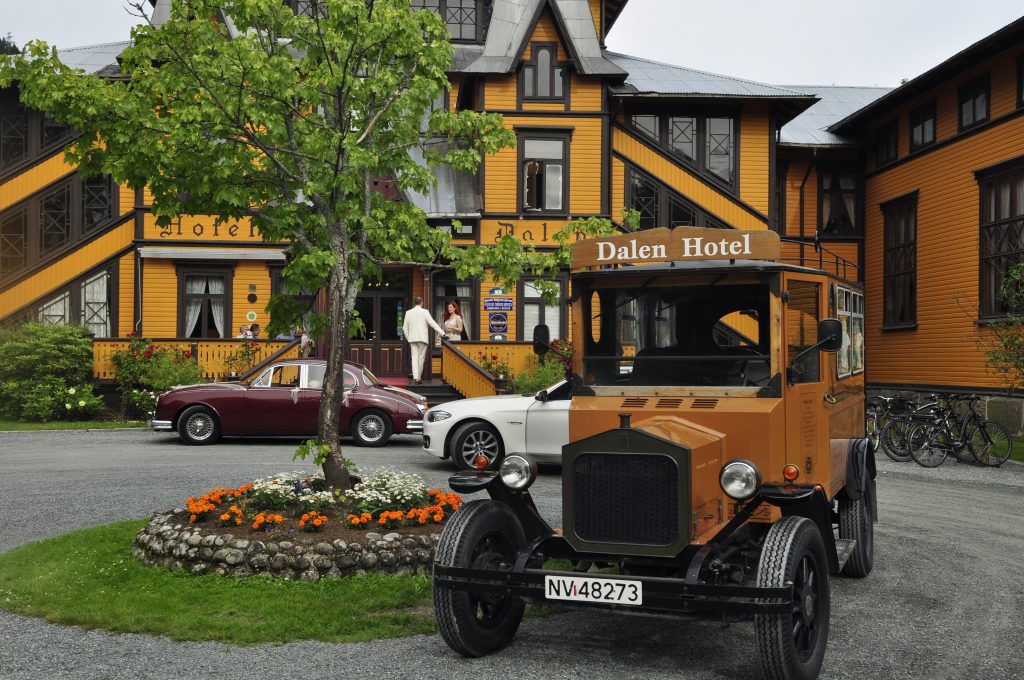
[754, 515, 829, 680]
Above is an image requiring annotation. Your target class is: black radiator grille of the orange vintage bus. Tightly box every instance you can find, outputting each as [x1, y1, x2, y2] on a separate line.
[572, 454, 679, 546]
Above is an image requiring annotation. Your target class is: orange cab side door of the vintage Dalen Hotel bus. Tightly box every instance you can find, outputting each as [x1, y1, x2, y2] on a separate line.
[772, 274, 835, 483]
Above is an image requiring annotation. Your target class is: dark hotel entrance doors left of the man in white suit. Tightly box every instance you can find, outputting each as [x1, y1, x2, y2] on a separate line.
[348, 271, 410, 377]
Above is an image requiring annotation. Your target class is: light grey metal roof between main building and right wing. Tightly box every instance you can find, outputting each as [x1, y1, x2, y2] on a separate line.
[779, 85, 892, 146]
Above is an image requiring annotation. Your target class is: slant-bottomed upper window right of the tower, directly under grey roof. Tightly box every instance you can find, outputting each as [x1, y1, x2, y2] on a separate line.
[629, 114, 738, 188]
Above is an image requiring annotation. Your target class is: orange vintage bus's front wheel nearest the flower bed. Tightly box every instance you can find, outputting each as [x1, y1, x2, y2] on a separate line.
[434, 500, 526, 656]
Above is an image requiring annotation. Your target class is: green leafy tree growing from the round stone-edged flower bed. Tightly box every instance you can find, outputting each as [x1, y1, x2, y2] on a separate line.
[0, 0, 610, 488]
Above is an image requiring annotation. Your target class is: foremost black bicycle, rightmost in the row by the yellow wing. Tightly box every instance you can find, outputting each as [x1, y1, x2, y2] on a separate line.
[907, 394, 1013, 467]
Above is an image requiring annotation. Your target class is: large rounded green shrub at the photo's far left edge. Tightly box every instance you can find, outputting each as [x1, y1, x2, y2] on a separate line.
[0, 323, 103, 422]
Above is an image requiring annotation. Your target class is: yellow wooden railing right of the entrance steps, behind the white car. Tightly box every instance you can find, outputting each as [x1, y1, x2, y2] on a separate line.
[441, 340, 534, 397]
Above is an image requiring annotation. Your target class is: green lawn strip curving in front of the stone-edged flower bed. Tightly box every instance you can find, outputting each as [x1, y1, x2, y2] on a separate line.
[0, 520, 435, 644]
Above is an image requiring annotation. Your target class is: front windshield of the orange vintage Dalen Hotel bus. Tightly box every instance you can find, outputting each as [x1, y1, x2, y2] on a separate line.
[584, 283, 771, 387]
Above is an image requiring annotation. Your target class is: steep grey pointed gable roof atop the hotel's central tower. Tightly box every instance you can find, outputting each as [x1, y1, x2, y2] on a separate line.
[462, 0, 626, 76]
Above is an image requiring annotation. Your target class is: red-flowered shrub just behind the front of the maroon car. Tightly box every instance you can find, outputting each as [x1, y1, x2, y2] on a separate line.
[112, 338, 203, 414]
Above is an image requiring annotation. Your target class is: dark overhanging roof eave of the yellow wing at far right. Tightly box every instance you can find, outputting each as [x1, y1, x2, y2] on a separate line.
[828, 16, 1024, 132]
